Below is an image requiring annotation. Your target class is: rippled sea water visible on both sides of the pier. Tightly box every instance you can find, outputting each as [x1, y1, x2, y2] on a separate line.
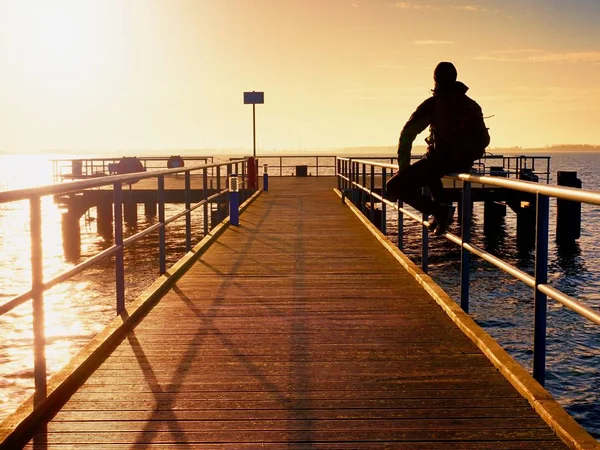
[0, 153, 600, 437]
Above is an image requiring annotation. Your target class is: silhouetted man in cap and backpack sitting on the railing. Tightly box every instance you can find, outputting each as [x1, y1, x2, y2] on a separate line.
[386, 62, 490, 236]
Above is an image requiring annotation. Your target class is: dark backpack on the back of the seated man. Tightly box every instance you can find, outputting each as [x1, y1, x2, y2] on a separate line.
[431, 94, 490, 162]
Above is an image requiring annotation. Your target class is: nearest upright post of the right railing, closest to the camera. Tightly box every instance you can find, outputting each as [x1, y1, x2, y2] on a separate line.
[533, 194, 550, 386]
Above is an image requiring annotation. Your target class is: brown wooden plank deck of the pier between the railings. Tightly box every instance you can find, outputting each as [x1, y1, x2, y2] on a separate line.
[28, 178, 565, 449]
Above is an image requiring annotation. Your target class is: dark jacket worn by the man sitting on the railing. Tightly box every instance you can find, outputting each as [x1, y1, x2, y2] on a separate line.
[398, 81, 475, 170]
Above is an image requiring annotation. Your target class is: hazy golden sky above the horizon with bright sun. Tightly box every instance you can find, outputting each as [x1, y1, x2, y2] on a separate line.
[0, 0, 600, 153]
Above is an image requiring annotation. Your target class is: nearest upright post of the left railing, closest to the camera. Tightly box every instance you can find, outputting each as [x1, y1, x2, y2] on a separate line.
[29, 196, 47, 406]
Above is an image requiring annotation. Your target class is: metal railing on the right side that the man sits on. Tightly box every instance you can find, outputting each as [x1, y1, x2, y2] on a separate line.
[337, 158, 600, 385]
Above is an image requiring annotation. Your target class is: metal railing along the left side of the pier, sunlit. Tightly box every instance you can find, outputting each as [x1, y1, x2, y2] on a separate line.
[0, 159, 249, 405]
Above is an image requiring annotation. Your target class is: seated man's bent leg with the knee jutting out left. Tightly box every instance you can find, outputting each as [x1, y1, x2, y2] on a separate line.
[386, 158, 441, 214]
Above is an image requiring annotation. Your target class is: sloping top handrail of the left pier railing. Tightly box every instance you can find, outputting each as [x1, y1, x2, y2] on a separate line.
[0, 160, 239, 203]
